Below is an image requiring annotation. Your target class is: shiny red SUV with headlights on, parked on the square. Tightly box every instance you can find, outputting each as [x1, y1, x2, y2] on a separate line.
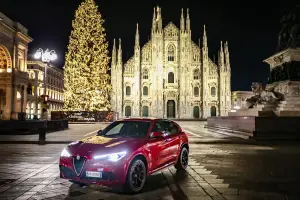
[59, 118, 189, 193]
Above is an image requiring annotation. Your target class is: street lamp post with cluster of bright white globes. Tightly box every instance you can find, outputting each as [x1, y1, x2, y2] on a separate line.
[34, 48, 57, 116]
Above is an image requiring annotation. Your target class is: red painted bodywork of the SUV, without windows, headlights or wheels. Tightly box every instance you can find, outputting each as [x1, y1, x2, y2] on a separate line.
[59, 118, 188, 185]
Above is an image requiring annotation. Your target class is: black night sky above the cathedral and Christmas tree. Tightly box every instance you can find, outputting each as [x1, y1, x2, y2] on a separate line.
[0, 0, 299, 90]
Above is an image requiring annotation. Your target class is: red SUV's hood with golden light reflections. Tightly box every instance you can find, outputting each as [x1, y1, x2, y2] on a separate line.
[68, 136, 145, 156]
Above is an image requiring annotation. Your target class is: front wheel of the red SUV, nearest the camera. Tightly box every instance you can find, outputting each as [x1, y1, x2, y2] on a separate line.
[123, 158, 147, 193]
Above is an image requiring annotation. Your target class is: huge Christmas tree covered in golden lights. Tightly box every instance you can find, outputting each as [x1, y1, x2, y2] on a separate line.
[64, 0, 111, 111]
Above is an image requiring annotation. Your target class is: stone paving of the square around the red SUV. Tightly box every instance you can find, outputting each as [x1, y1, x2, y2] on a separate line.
[0, 124, 300, 200]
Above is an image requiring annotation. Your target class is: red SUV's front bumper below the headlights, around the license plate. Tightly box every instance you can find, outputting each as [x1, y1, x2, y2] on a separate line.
[59, 157, 127, 185]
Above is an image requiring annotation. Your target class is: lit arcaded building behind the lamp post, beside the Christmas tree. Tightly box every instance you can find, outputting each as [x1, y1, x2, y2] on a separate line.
[26, 61, 64, 119]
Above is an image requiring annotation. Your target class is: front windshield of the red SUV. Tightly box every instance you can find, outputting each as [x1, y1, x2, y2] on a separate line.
[99, 121, 150, 138]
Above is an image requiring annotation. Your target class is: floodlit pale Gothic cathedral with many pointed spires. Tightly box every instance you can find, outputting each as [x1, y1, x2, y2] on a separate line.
[111, 7, 231, 119]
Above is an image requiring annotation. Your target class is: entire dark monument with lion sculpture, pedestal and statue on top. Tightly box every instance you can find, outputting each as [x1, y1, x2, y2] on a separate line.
[207, 6, 300, 139]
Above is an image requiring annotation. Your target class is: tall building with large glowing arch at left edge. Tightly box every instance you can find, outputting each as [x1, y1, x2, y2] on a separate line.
[0, 13, 32, 120]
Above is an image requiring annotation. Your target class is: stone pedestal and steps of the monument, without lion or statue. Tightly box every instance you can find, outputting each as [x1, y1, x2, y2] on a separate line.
[207, 48, 300, 139]
